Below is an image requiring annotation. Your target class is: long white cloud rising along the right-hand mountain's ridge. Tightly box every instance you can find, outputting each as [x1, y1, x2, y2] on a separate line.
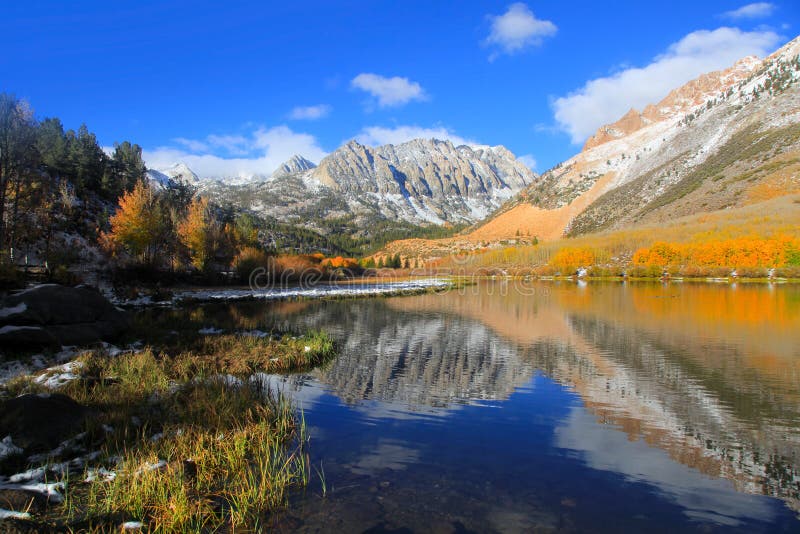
[553, 27, 780, 144]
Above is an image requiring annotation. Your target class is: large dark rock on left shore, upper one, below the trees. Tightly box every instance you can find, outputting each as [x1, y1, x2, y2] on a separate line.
[0, 284, 128, 349]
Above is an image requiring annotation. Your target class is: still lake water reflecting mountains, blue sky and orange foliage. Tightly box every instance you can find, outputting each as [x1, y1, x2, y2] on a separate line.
[175, 282, 800, 532]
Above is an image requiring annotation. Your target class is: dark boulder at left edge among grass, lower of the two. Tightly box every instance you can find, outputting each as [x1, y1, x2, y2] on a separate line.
[0, 393, 89, 455]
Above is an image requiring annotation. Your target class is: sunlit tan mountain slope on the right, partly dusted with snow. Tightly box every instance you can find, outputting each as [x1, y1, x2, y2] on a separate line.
[387, 34, 800, 264]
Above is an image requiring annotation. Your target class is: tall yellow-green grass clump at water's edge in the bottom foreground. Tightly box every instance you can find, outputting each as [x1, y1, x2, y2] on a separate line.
[72, 381, 308, 532]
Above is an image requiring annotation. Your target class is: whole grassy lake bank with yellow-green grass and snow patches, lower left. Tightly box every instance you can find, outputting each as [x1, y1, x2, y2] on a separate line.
[0, 333, 335, 532]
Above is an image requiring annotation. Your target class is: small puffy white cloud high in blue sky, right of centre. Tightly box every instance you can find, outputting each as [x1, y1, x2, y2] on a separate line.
[485, 2, 558, 60]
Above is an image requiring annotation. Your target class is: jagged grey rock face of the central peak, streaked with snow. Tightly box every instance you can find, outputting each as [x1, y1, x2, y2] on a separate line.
[310, 139, 536, 224]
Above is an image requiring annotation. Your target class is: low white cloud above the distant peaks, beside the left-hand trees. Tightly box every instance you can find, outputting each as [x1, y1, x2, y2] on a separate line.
[144, 125, 326, 177]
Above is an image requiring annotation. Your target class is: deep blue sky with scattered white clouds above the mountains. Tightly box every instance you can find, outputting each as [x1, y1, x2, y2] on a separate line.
[0, 0, 800, 178]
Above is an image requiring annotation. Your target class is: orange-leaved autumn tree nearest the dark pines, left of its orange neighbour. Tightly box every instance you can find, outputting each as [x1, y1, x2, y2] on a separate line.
[101, 180, 166, 265]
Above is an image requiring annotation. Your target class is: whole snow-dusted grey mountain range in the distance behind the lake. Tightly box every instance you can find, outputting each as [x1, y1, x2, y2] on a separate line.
[161, 139, 537, 241]
